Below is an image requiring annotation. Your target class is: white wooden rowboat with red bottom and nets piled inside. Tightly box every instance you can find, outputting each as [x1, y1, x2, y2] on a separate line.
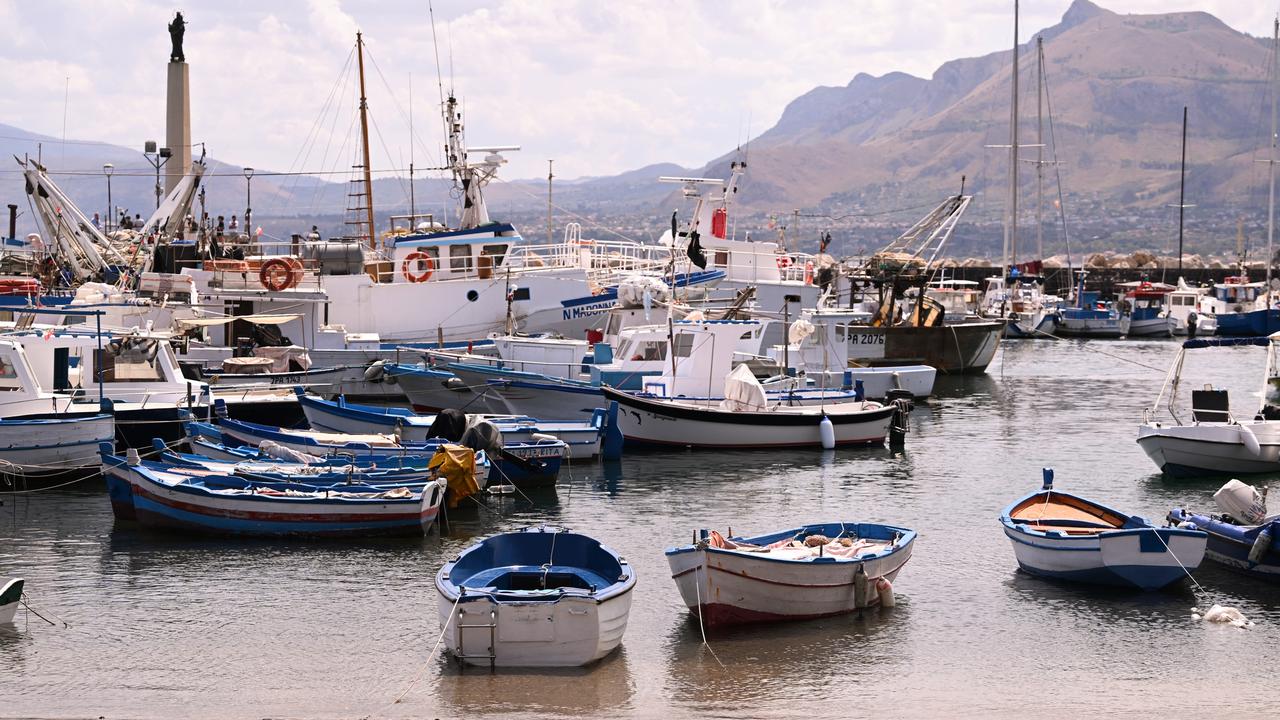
[667, 523, 915, 628]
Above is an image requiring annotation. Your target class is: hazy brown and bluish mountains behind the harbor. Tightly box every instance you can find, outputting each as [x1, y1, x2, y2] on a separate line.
[0, 0, 1271, 254]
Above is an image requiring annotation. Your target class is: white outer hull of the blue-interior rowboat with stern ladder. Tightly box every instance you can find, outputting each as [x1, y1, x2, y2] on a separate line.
[436, 589, 631, 667]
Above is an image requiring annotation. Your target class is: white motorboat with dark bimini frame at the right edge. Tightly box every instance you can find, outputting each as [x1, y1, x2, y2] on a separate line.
[1138, 333, 1280, 477]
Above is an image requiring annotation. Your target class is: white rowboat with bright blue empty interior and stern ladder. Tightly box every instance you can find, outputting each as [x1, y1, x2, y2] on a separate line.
[435, 527, 636, 667]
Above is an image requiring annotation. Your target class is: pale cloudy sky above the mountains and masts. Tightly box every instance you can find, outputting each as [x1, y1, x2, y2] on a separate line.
[0, 0, 1280, 179]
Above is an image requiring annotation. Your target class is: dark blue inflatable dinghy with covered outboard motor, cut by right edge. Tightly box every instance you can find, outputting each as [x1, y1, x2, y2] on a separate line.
[1169, 480, 1280, 582]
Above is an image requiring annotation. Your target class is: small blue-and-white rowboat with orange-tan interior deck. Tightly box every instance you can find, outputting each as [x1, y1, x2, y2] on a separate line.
[1000, 468, 1208, 589]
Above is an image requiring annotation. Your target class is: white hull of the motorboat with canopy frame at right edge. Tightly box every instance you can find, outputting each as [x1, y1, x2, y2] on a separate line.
[1138, 420, 1280, 477]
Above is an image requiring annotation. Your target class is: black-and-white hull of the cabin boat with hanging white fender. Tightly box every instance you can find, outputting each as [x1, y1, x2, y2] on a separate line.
[604, 388, 895, 448]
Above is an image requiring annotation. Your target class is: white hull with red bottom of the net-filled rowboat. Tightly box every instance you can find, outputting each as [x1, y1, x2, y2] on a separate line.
[667, 544, 911, 624]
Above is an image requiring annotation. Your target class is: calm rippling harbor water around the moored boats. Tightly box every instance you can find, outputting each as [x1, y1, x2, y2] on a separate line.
[0, 341, 1280, 717]
